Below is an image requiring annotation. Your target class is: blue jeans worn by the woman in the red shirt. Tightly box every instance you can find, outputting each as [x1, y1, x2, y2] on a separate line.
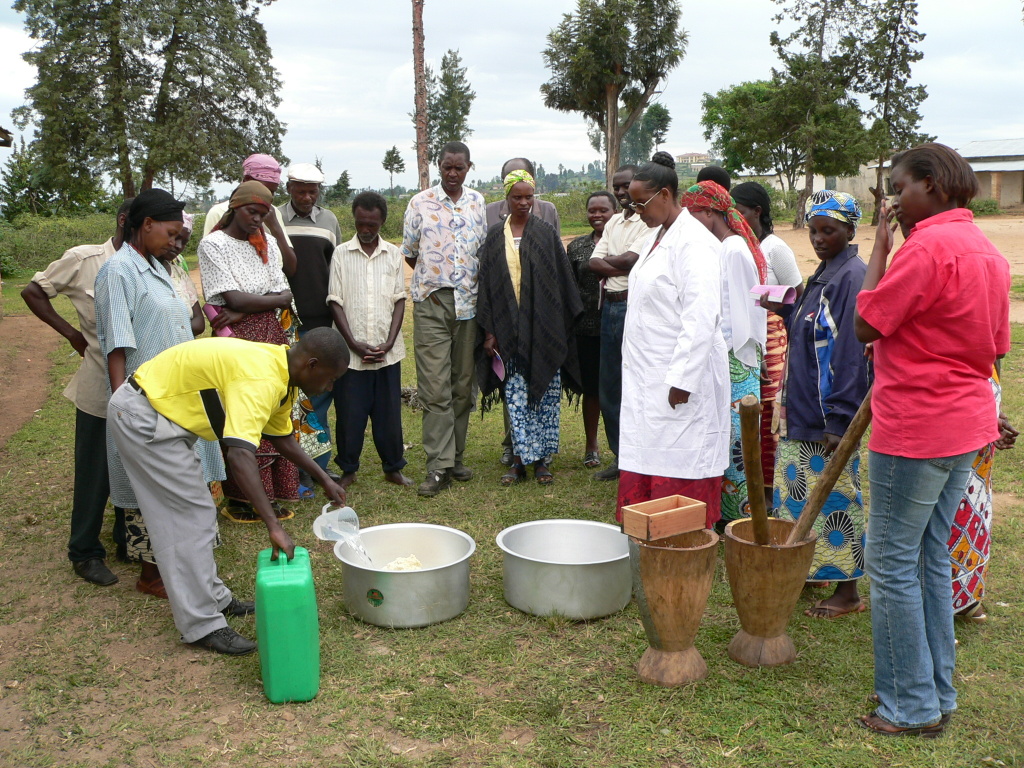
[865, 450, 978, 728]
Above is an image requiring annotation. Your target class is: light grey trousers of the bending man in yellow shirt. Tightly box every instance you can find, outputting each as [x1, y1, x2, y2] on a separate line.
[106, 383, 231, 643]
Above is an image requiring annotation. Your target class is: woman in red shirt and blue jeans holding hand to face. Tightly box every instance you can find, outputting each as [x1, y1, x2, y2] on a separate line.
[855, 143, 1010, 736]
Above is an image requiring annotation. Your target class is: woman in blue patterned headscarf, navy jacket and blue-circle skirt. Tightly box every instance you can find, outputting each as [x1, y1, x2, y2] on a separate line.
[771, 189, 868, 618]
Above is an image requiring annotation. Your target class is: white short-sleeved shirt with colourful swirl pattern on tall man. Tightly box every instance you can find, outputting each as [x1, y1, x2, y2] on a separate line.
[401, 184, 487, 319]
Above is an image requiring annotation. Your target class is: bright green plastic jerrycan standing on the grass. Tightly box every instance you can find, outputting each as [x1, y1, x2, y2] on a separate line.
[256, 547, 319, 703]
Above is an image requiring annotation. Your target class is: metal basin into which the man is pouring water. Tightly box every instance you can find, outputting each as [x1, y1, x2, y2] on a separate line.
[334, 522, 476, 627]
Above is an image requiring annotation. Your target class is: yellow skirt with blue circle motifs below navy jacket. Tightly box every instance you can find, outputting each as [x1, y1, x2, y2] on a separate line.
[775, 437, 867, 582]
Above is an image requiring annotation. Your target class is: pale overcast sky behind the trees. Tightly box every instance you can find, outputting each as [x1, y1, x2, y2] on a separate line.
[0, 0, 1024, 195]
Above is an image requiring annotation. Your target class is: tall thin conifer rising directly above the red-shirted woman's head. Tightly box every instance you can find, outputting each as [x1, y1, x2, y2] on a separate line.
[857, 0, 931, 224]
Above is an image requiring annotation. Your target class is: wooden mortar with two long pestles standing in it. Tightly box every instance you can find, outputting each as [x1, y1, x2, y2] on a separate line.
[725, 518, 816, 667]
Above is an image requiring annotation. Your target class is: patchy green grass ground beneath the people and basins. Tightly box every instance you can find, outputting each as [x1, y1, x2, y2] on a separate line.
[0, 280, 1024, 768]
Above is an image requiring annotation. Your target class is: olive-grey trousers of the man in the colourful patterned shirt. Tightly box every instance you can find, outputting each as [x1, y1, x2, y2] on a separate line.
[413, 289, 477, 472]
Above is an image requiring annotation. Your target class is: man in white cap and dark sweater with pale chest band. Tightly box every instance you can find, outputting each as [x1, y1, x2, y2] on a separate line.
[278, 163, 342, 488]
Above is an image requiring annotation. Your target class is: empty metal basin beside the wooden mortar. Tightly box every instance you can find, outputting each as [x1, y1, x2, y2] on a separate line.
[497, 520, 633, 620]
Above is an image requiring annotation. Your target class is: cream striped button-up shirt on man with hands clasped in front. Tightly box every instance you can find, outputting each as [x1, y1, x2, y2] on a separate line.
[327, 238, 406, 371]
